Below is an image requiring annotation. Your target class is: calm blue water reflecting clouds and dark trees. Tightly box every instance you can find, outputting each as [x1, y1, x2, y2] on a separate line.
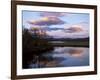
[29, 47, 89, 68]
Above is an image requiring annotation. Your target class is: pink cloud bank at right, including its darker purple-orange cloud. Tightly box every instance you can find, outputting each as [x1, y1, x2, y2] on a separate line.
[47, 24, 89, 38]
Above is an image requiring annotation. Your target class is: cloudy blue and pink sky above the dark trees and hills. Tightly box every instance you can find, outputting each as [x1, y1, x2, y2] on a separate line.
[22, 11, 90, 38]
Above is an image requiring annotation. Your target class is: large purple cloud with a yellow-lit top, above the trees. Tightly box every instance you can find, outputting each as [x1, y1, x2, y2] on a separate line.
[28, 16, 64, 26]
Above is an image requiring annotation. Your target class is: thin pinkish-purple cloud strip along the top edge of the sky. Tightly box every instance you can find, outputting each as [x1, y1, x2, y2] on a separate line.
[40, 12, 67, 17]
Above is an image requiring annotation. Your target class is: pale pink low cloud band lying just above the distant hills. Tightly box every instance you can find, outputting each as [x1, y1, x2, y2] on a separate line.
[47, 30, 89, 39]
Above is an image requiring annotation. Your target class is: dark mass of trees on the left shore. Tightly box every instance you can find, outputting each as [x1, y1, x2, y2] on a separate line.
[22, 29, 54, 68]
